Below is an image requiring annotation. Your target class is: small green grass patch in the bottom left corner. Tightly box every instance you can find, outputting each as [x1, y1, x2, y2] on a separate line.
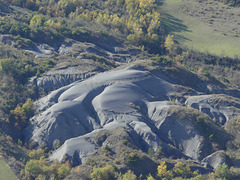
[0, 158, 17, 180]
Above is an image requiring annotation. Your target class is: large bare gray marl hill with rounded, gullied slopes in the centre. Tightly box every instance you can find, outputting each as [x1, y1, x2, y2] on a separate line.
[23, 61, 240, 168]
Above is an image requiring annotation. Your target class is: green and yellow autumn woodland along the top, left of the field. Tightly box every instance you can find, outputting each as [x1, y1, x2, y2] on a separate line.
[1, 0, 166, 52]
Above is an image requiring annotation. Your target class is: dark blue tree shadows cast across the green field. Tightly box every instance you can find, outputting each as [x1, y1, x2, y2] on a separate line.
[162, 13, 190, 41]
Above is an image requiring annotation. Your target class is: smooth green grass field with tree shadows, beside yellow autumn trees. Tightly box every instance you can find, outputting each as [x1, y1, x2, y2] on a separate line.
[161, 0, 240, 57]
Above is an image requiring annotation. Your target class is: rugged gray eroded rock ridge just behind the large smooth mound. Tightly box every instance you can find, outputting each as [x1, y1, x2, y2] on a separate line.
[27, 38, 145, 93]
